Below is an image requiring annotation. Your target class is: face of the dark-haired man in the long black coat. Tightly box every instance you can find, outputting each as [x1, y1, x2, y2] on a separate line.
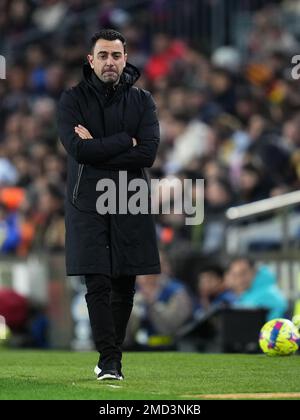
[87, 39, 127, 84]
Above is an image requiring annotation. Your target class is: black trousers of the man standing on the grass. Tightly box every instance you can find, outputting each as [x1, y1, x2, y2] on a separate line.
[84, 274, 136, 363]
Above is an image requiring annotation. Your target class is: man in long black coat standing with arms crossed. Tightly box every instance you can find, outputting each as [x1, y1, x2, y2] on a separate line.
[58, 29, 160, 380]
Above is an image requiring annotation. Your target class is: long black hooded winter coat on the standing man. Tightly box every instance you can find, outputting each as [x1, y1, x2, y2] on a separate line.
[58, 64, 160, 277]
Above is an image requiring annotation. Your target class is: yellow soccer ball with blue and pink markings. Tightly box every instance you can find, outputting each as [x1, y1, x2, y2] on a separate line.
[259, 318, 300, 356]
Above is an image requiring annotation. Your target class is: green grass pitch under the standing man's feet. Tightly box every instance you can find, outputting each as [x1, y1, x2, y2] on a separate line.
[0, 350, 300, 400]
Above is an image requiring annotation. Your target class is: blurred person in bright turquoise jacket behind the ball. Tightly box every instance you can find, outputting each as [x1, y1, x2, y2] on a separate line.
[226, 257, 288, 320]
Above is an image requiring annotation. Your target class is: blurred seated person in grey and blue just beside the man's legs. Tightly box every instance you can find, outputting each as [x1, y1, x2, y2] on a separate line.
[126, 254, 193, 349]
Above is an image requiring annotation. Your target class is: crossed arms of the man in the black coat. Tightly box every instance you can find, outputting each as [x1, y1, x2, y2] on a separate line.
[58, 93, 159, 169]
